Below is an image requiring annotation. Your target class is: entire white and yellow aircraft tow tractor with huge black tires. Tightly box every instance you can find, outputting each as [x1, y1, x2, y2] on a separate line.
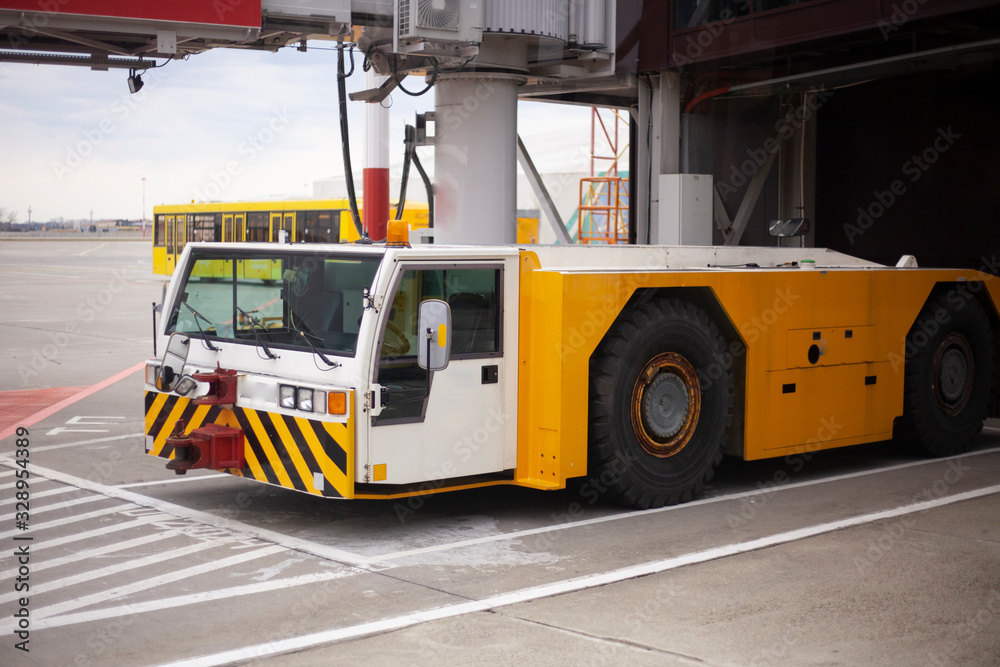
[145, 243, 1000, 507]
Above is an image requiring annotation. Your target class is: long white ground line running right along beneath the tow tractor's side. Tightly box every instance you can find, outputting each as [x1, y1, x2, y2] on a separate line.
[364, 447, 1000, 566]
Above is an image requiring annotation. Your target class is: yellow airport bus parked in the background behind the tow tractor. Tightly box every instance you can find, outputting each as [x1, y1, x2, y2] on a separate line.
[153, 199, 429, 277]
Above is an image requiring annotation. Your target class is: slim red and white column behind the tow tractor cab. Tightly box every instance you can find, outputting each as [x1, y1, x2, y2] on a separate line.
[362, 68, 389, 241]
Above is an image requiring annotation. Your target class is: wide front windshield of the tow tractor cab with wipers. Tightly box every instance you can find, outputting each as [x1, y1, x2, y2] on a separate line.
[167, 249, 380, 356]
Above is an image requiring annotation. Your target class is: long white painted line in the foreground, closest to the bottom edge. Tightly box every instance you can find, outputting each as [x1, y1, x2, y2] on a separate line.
[161, 485, 1000, 667]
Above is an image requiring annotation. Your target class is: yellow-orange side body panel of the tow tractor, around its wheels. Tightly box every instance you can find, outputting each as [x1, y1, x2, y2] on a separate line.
[516, 251, 1000, 488]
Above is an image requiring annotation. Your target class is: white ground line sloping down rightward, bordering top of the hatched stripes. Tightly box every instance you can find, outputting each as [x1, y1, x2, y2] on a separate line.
[0, 457, 370, 565]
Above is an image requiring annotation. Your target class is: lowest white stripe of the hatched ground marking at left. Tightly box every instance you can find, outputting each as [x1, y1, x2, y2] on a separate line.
[32, 570, 360, 629]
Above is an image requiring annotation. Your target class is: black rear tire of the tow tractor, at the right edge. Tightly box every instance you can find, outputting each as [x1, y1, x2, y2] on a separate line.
[895, 291, 996, 457]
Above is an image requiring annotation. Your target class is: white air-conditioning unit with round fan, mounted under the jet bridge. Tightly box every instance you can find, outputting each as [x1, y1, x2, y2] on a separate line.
[393, 0, 485, 54]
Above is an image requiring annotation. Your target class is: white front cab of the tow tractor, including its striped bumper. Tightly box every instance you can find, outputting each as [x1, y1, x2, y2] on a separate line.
[146, 243, 518, 498]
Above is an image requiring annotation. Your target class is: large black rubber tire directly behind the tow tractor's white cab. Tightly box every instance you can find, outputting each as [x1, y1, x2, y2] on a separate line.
[588, 298, 735, 509]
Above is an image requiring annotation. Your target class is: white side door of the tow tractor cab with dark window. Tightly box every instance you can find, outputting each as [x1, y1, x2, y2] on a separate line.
[365, 260, 517, 484]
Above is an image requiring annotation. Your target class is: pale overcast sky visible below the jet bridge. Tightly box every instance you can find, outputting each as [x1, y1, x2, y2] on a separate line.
[0, 42, 590, 222]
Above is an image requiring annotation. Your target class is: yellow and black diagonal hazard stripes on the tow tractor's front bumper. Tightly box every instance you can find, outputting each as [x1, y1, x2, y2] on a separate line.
[146, 391, 354, 498]
